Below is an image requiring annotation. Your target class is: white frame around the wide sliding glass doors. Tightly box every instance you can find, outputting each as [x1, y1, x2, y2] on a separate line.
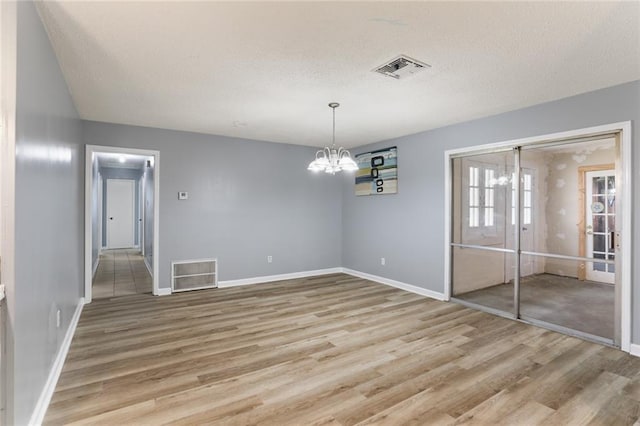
[444, 121, 633, 352]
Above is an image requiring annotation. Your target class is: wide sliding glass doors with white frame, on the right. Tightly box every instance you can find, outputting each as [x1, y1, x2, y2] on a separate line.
[446, 123, 631, 351]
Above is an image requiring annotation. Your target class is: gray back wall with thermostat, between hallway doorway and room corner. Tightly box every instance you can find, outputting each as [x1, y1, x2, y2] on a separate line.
[83, 122, 342, 288]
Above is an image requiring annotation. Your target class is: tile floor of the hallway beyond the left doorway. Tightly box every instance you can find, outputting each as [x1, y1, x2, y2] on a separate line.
[92, 249, 152, 299]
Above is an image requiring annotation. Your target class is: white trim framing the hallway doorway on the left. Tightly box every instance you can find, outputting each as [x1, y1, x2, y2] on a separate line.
[84, 145, 160, 303]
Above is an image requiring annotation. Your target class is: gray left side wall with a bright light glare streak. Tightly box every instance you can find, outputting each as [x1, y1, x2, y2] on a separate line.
[13, 2, 84, 425]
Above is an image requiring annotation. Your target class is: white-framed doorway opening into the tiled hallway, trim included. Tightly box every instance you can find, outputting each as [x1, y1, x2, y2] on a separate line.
[85, 145, 159, 303]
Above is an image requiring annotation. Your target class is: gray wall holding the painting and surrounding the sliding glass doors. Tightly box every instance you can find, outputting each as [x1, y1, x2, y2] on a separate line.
[342, 81, 640, 342]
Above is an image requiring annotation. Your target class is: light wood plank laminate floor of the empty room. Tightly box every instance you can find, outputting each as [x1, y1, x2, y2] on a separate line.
[45, 274, 640, 425]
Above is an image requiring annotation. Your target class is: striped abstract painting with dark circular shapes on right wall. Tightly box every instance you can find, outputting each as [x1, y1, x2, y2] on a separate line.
[356, 146, 398, 195]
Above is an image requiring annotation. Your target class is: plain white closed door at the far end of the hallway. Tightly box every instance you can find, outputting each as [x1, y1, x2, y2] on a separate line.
[107, 179, 135, 249]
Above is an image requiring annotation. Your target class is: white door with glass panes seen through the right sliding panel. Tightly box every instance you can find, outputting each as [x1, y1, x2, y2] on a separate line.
[585, 170, 616, 284]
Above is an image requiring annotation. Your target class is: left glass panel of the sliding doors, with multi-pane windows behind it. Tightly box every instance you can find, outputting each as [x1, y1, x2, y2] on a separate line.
[451, 150, 516, 313]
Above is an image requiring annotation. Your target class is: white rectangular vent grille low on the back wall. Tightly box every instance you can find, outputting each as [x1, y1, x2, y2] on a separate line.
[171, 259, 218, 292]
